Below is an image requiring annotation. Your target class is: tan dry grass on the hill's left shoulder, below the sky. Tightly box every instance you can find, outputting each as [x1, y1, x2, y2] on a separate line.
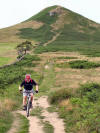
[0, 21, 43, 43]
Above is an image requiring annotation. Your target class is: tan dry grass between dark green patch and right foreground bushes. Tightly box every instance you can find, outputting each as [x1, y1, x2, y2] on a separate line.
[55, 68, 100, 88]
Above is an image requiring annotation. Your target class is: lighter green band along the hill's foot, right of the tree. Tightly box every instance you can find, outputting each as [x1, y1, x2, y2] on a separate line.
[35, 40, 100, 57]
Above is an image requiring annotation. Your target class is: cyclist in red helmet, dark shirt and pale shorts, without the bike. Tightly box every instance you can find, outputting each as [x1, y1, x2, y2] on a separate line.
[19, 74, 38, 110]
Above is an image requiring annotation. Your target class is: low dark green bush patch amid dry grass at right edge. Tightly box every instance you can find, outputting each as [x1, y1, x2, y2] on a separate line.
[69, 60, 100, 69]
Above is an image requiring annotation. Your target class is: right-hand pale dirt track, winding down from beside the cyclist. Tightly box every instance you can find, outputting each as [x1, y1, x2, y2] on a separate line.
[34, 96, 65, 133]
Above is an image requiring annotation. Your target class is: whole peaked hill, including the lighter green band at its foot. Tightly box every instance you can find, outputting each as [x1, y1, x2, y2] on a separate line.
[0, 6, 100, 58]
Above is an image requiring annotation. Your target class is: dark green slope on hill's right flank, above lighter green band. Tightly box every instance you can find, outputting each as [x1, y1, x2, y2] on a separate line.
[58, 21, 100, 41]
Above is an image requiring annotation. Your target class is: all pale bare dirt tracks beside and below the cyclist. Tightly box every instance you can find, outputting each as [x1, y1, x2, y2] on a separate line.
[16, 96, 65, 133]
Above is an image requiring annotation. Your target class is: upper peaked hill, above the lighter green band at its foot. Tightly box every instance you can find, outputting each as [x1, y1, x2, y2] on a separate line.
[0, 6, 100, 44]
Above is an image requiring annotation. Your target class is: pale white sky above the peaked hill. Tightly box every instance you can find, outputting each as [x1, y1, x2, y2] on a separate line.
[0, 0, 100, 29]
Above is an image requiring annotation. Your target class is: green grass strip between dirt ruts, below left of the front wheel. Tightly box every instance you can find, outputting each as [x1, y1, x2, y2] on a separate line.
[16, 114, 29, 133]
